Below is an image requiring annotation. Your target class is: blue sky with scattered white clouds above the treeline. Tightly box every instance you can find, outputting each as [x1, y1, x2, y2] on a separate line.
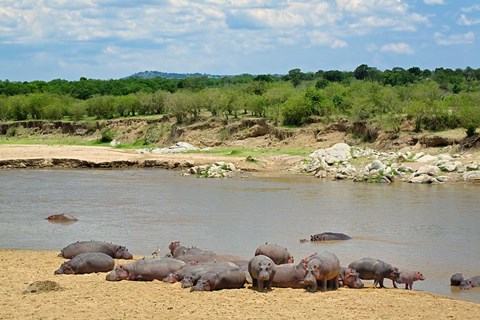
[0, 0, 480, 81]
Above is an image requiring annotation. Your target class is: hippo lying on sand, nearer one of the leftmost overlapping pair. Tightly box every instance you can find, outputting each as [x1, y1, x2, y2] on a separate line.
[54, 252, 115, 274]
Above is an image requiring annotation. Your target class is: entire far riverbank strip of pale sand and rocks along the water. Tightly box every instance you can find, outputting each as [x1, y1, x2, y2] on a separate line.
[0, 142, 480, 184]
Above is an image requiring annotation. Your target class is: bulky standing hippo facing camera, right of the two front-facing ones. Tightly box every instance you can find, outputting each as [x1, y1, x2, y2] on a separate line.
[302, 251, 340, 292]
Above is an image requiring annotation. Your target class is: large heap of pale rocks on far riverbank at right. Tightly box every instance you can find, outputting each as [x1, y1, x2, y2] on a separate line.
[297, 143, 480, 184]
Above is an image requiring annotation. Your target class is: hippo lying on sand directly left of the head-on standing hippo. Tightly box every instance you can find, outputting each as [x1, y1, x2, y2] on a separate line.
[191, 268, 247, 291]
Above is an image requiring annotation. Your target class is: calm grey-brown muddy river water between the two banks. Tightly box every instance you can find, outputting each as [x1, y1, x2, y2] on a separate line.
[0, 170, 480, 303]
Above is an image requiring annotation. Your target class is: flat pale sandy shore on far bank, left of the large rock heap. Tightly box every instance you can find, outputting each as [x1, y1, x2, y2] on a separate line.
[0, 144, 303, 175]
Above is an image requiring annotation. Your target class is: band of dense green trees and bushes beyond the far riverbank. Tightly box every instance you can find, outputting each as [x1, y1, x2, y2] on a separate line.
[0, 64, 480, 135]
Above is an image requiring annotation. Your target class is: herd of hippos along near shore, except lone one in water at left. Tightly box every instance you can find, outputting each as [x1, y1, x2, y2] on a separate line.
[55, 233, 480, 292]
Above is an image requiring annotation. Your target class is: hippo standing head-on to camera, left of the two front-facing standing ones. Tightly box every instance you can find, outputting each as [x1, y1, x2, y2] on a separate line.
[248, 254, 276, 291]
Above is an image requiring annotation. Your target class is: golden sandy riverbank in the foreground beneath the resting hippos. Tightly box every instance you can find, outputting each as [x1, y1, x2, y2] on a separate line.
[0, 249, 480, 320]
